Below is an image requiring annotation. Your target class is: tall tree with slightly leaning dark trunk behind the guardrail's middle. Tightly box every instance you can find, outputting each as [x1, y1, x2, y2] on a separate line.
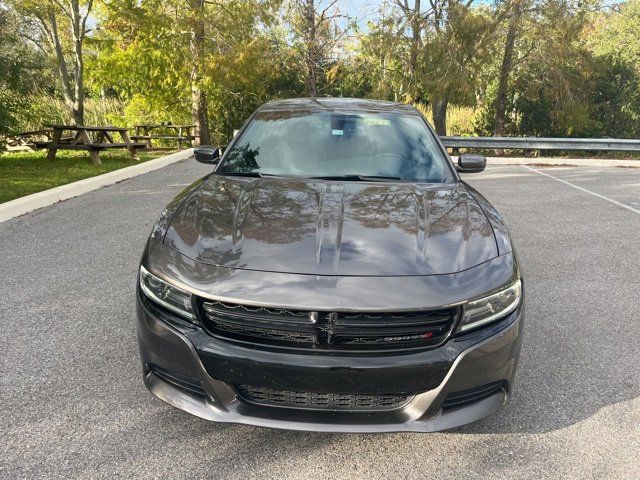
[477, 0, 596, 137]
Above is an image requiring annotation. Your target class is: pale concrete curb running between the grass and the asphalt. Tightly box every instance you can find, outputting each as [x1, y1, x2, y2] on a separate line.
[0, 148, 193, 223]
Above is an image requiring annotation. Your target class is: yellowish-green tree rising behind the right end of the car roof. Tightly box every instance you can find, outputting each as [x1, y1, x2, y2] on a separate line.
[361, 0, 500, 135]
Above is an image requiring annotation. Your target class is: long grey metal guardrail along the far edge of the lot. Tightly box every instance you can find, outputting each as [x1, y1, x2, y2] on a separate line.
[441, 137, 640, 152]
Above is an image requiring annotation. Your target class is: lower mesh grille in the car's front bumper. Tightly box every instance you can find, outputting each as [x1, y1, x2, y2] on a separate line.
[235, 385, 411, 411]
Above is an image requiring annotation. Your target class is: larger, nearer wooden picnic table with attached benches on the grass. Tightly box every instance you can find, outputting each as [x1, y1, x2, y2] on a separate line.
[35, 125, 147, 164]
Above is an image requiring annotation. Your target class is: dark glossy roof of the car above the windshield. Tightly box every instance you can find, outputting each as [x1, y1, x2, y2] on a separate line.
[258, 97, 420, 115]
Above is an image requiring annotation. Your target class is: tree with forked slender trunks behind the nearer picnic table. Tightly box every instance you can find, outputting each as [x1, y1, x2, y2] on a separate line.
[10, 0, 93, 125]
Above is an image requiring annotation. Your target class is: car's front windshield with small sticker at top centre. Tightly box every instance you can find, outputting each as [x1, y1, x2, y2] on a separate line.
[216, 111, 454, 183]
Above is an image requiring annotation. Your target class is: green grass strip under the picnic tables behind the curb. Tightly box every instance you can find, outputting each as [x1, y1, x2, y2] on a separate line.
[0, 150, 167, 203]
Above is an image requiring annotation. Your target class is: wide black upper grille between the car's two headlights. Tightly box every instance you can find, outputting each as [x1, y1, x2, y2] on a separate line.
[202, 301, 458, 350]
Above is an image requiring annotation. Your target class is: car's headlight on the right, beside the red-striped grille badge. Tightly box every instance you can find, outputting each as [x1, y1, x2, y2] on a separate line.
[458, 279, 522, 332]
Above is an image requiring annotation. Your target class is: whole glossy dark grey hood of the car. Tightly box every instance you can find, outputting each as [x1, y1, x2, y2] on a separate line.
[164, 175, 498, 276]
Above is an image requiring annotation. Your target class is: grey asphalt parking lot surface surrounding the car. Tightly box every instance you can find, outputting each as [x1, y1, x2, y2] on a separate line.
[0, 161, 640, 479]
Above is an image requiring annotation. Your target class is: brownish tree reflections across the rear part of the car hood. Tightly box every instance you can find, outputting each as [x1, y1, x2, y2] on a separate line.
[166, 176, 492, 267]
